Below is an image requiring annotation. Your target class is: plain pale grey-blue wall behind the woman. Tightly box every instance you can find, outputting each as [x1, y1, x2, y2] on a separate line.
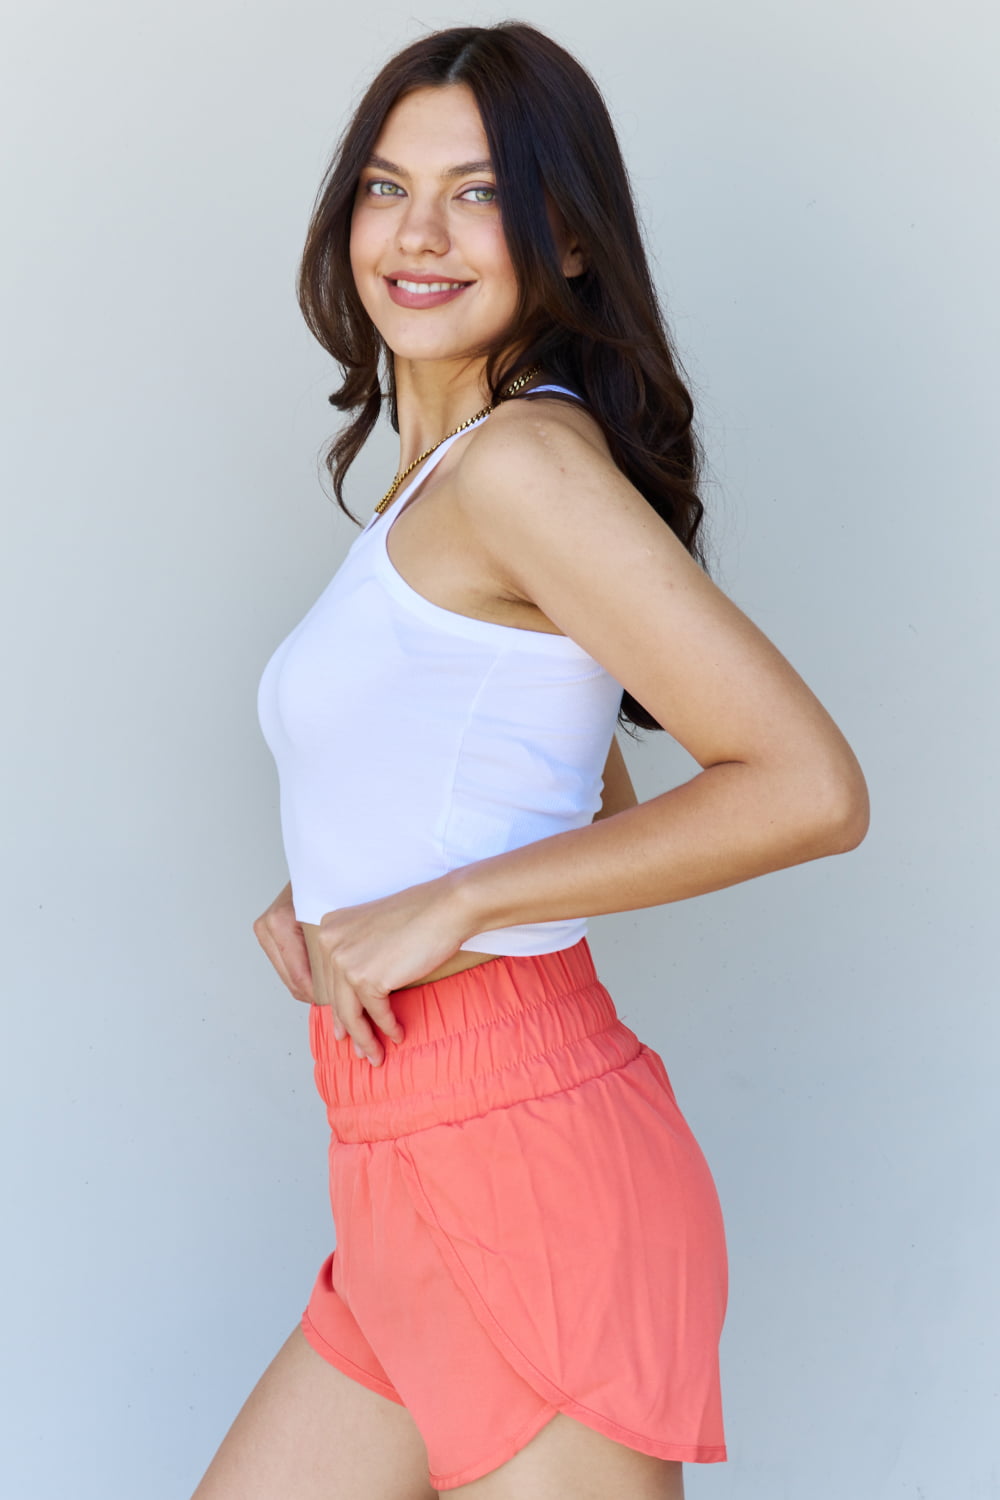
[0, 0, 1000, 1500]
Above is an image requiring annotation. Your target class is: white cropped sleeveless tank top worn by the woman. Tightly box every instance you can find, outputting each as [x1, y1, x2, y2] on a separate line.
[258, 386, 622, 956]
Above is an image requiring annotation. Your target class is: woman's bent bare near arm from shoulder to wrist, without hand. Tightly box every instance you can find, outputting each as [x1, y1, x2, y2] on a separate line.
[447, 408, 868, 939]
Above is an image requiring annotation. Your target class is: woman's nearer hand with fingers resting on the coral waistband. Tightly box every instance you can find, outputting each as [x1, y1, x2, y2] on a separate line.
[313, 875, 469, 1067]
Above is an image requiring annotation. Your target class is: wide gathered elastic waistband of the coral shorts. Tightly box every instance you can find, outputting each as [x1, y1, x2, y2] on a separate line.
[309, 938, 643, 1142]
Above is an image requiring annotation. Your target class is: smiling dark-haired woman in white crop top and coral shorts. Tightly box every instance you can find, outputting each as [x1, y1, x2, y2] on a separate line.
[196, 23, 868, 1500]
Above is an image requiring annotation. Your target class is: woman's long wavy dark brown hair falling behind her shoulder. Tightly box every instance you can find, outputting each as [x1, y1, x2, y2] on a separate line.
[297, 21, 708, 732]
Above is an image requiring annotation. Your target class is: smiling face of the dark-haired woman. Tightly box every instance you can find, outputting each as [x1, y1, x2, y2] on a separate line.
[351, 84, 517, 372]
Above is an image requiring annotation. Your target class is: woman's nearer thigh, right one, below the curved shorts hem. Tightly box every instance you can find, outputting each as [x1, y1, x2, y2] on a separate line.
[441, 1412, 684, 1500]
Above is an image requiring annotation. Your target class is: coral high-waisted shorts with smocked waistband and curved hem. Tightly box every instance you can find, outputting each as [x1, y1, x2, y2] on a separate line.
[301, 938, 729, 1490]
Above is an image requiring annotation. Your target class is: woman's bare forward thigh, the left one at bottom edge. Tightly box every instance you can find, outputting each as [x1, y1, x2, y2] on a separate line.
[192, 1326, 438, 1500]
